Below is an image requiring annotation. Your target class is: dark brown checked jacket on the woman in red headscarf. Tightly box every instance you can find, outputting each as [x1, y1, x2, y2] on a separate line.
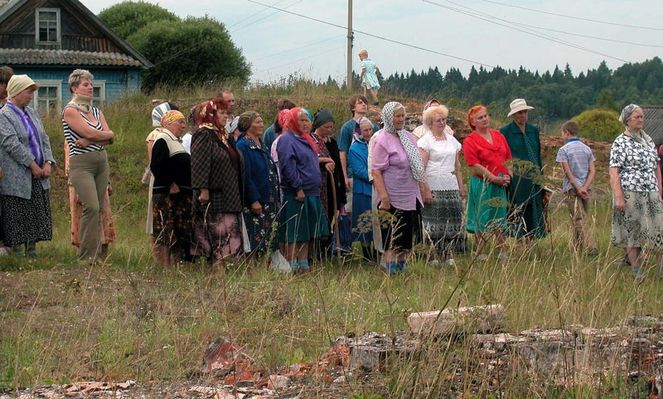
[191, 128, 243, 213]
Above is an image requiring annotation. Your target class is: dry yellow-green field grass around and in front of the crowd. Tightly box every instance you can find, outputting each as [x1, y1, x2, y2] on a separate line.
[0, 87, 663, 398]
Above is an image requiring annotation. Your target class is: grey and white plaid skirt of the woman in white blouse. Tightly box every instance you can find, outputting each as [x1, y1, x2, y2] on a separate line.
[421, 190, 467, 252]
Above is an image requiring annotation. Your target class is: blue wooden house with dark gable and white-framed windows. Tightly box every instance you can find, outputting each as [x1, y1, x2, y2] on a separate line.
[0, 0, 153, 113]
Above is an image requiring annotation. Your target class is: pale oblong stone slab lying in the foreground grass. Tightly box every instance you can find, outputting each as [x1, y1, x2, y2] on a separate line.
[407, 304, 506, 336]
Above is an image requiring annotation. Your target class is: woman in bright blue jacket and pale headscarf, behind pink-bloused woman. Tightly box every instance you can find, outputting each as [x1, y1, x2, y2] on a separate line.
[348, 117, 376, 260]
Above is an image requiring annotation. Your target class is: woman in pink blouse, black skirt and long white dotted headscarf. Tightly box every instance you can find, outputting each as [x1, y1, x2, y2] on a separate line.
[371, 102, 426, 275]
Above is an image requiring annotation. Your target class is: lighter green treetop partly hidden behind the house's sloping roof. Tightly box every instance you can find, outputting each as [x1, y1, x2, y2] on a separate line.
[99, 1, 180, 40]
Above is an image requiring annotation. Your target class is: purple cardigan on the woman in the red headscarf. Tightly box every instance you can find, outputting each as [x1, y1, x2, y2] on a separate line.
[276, 131, 322, 197]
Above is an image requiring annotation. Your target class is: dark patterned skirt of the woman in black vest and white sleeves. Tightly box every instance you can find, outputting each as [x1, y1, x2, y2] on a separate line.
[152, 191, 192, 260]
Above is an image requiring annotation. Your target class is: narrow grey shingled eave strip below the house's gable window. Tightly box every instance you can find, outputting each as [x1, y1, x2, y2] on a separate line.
[0, 48, 143, 67]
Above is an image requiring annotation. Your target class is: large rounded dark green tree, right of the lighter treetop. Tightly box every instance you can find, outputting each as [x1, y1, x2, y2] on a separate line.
[128, 17, 251, 90]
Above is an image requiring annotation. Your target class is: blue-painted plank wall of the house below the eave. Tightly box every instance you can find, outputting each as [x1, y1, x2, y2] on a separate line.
[14, 67, 140, 105]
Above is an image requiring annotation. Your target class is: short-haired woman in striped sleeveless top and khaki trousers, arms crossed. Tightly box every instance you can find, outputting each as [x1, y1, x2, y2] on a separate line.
[62, 69, 115, 262]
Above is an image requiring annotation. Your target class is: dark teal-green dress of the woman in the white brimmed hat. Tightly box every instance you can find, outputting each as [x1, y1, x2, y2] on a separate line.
[500, 122, 547, 238]
